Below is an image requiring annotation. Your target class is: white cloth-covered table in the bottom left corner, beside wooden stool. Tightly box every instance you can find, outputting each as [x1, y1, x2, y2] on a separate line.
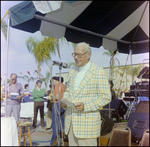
[1, 117, 19, 146]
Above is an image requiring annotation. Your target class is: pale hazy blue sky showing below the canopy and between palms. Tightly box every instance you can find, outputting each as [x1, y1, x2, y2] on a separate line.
[1, 1, 149, 91]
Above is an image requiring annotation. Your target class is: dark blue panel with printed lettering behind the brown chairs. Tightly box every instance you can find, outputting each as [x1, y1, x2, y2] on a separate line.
[127, 112, 149, 143]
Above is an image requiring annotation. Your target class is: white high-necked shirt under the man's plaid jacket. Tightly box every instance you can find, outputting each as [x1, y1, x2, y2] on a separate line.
[75, 61, 91, 90]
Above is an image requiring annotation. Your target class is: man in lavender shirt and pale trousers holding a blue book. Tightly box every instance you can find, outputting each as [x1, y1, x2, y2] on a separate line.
[2, 73, 23, 121]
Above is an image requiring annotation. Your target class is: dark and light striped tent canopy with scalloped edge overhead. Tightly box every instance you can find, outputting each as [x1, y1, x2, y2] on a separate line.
[9, 1, 149, 54]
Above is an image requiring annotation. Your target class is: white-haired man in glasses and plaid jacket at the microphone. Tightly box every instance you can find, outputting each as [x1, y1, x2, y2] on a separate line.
[61, 43, 111, 146]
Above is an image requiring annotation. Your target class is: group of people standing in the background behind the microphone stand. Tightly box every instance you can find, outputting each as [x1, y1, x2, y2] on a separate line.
[1, 73, 66, 143]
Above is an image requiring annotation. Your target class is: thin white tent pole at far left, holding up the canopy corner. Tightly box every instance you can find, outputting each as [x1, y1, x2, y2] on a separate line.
[5, 13, 10, 117]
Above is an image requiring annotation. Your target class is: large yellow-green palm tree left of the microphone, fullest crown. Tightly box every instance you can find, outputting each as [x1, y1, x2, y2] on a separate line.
[26, 37, 60, 79]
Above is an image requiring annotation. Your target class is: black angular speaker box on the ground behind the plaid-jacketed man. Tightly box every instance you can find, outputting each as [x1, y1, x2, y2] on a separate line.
[103, 99, 127, 117]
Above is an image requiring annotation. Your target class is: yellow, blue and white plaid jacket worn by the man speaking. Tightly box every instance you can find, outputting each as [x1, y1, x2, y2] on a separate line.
[63, 62, 111, 138]
